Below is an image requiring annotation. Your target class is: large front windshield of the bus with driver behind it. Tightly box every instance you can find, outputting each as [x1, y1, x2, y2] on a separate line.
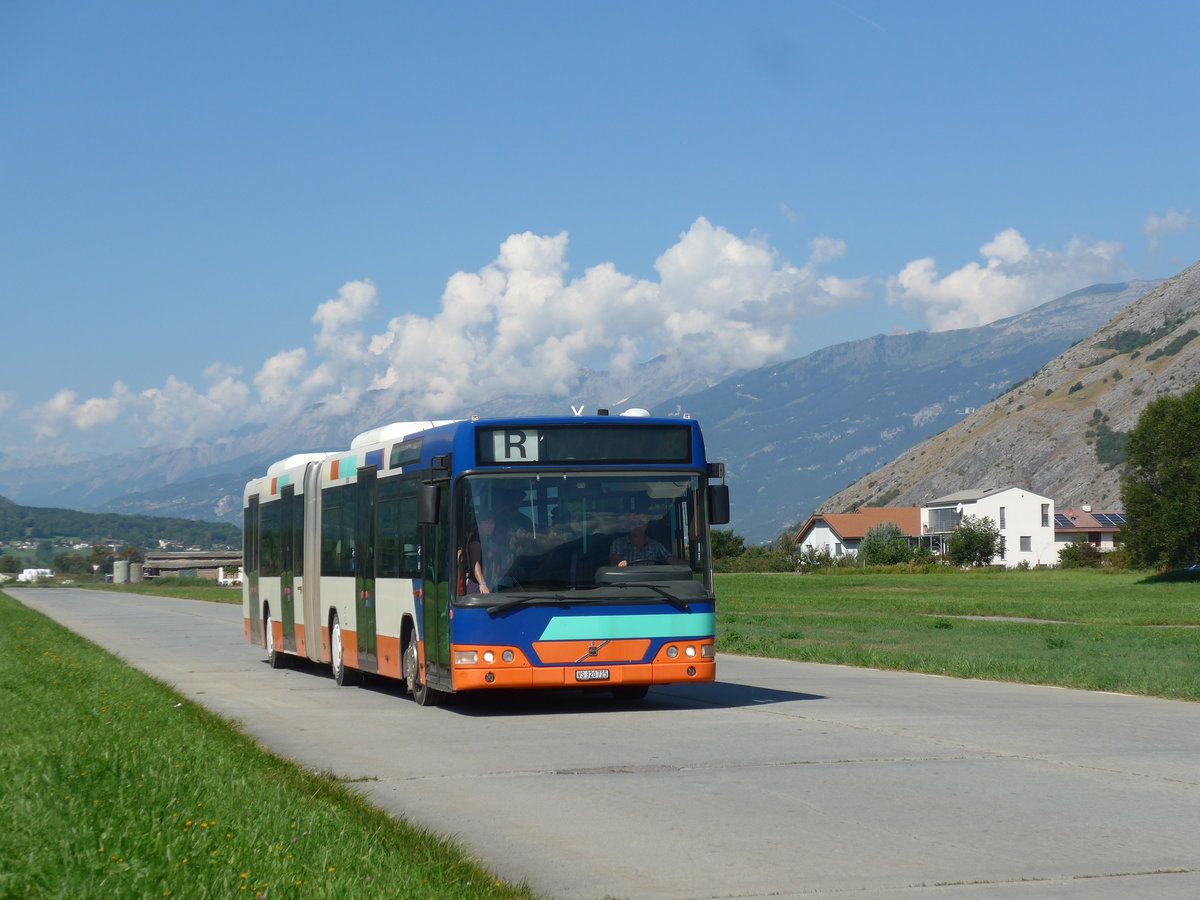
[456, 470, 710, 602]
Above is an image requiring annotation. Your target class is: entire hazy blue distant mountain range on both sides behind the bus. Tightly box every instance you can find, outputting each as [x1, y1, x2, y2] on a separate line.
[0, 270, 1171, 542]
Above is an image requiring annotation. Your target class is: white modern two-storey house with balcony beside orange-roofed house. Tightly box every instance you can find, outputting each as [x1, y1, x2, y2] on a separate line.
[920, 487, 1058, 569]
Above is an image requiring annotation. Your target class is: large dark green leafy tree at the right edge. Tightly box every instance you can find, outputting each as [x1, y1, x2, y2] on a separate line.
[1121, 385, 1200, 569]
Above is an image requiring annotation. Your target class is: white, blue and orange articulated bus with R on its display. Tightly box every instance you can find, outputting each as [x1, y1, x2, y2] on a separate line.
[242, 410, 730, 706]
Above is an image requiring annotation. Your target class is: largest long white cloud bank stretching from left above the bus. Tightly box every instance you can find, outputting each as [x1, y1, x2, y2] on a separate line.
[9, 218, 868, 445]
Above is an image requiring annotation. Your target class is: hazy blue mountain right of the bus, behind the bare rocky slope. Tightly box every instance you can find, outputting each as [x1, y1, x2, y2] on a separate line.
[654, 282, 1159, 542]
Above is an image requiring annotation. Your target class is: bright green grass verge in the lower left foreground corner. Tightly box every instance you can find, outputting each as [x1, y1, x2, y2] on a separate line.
[0, 594, 532, 900]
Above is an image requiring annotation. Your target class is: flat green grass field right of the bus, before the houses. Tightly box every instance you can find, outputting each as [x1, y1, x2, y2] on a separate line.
[716, 569, 1200, 700]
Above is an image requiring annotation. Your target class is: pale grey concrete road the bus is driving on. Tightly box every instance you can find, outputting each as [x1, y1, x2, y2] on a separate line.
[8, 588, 1200, 900]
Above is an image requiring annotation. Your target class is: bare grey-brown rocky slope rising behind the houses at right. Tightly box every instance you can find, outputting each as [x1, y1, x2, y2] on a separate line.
[820, 263, 1200, 512]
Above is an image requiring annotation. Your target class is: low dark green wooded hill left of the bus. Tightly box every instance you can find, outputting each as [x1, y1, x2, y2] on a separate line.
[0, 497, 241, 550]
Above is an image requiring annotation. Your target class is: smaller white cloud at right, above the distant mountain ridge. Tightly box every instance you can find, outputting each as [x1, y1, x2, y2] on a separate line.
[887, 228, 1122, 331]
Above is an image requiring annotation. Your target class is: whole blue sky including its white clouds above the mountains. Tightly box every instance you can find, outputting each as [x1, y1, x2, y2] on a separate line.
[0, 0, 1200, 455]
